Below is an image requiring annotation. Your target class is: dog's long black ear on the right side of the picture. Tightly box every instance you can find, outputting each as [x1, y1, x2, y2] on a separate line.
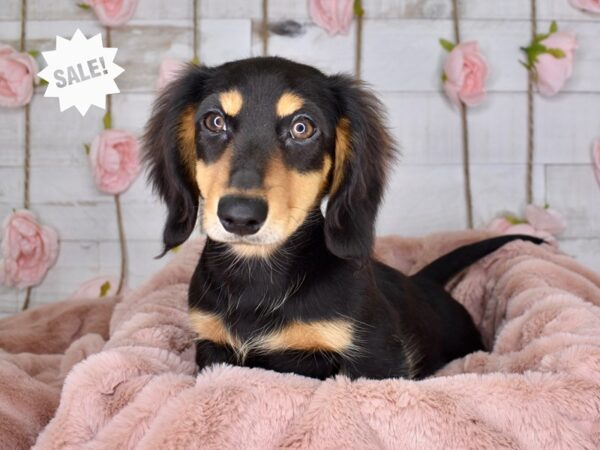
[325, 75, 395, 262]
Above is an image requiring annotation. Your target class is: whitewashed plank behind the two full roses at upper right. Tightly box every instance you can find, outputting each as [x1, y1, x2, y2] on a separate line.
[363, 20, 600, 92]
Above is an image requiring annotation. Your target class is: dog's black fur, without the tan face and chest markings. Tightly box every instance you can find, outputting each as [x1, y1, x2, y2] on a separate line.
[145, 58, 541, 378]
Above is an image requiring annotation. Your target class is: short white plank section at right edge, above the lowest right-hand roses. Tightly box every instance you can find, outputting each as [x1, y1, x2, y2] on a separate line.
[546, 164, 600, 239]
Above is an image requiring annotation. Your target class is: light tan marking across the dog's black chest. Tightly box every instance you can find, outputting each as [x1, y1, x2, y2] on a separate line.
[190, 309, 356, 360]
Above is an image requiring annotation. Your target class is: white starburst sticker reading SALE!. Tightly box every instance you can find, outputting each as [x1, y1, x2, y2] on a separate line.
[38, 29, 123, 116]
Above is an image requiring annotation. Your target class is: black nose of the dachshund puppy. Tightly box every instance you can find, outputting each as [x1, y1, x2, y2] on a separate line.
[217, 195, 268, 236]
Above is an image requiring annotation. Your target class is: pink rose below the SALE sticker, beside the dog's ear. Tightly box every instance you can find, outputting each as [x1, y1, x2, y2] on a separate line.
[90, 129, 140, 194]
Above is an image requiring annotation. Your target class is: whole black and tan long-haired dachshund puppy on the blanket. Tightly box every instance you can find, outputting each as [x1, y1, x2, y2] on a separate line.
[145, 58, 539, 378]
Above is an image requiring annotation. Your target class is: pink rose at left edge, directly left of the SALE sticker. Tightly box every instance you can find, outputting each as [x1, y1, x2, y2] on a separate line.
[0, 44, 38, 107]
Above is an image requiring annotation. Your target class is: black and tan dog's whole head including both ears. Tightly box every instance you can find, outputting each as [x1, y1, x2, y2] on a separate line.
[144, 58, 393, 259]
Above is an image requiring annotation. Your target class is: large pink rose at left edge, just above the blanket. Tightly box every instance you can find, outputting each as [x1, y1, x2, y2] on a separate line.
[0, 209, 58, 289]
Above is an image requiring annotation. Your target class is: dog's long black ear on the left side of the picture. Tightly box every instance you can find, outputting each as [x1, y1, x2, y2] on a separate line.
[143, 65, 210, 256]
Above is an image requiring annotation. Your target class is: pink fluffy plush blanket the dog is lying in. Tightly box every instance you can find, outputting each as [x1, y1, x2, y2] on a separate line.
[0, 232, 600, 449]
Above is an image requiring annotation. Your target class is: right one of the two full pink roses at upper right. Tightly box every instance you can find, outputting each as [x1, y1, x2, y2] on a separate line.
[534, 31, 577, 97]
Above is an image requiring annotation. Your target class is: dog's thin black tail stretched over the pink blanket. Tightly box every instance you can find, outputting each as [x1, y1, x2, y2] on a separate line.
[414, 234, 545, 284]
